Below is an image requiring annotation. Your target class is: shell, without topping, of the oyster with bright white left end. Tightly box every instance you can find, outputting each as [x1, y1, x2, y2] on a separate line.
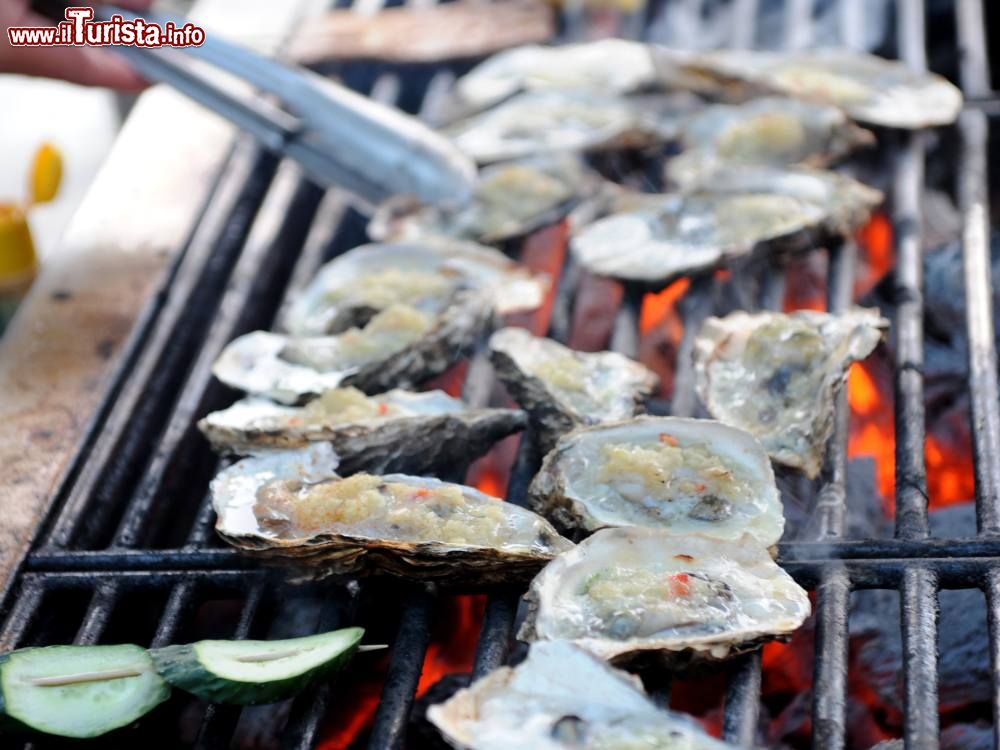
[212, 290, 495, 404]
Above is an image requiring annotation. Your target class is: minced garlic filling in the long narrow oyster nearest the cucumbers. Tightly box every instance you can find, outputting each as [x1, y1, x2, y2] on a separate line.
[254, 474, 557, 547]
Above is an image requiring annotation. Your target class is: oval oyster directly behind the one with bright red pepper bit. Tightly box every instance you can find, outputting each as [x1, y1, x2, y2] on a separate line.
[529, 417, 785, 547]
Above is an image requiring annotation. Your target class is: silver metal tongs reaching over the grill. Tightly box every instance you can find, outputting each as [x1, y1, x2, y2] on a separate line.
[42, 5, 476, 209]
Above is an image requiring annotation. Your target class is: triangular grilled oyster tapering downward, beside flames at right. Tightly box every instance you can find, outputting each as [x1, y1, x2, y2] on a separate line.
[694, 308, 889, 478]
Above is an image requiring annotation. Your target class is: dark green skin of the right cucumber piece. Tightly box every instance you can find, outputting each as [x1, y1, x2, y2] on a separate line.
[149, 639, 360, 706]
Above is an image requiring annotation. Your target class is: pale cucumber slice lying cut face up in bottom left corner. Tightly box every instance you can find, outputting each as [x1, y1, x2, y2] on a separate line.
[0, 645, 170, 737]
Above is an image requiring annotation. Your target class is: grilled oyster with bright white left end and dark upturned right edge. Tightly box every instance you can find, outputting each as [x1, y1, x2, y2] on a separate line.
[212, 289, 494, 404]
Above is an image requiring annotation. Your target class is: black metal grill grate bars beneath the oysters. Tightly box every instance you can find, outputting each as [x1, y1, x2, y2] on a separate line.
[0, 0, 1000, 749]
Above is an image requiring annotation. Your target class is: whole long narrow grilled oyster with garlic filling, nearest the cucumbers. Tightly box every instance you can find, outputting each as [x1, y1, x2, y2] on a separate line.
[211, 443, 572, 584]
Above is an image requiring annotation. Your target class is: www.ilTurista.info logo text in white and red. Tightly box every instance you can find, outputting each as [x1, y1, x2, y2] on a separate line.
[7, 8, 205, 47]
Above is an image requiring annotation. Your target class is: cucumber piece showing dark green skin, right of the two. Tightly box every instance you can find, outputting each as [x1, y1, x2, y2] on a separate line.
[150, 628, 365, 706]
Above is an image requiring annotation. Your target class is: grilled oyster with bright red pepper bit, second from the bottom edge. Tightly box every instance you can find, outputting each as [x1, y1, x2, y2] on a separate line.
[518, 527, 809, 663]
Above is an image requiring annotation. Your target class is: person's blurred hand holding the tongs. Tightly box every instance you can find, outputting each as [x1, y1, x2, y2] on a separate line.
[0, 0, 152, 91]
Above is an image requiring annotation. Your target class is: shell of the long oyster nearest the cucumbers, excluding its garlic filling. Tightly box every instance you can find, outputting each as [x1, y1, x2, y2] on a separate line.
[211, 443, 572, 585]
